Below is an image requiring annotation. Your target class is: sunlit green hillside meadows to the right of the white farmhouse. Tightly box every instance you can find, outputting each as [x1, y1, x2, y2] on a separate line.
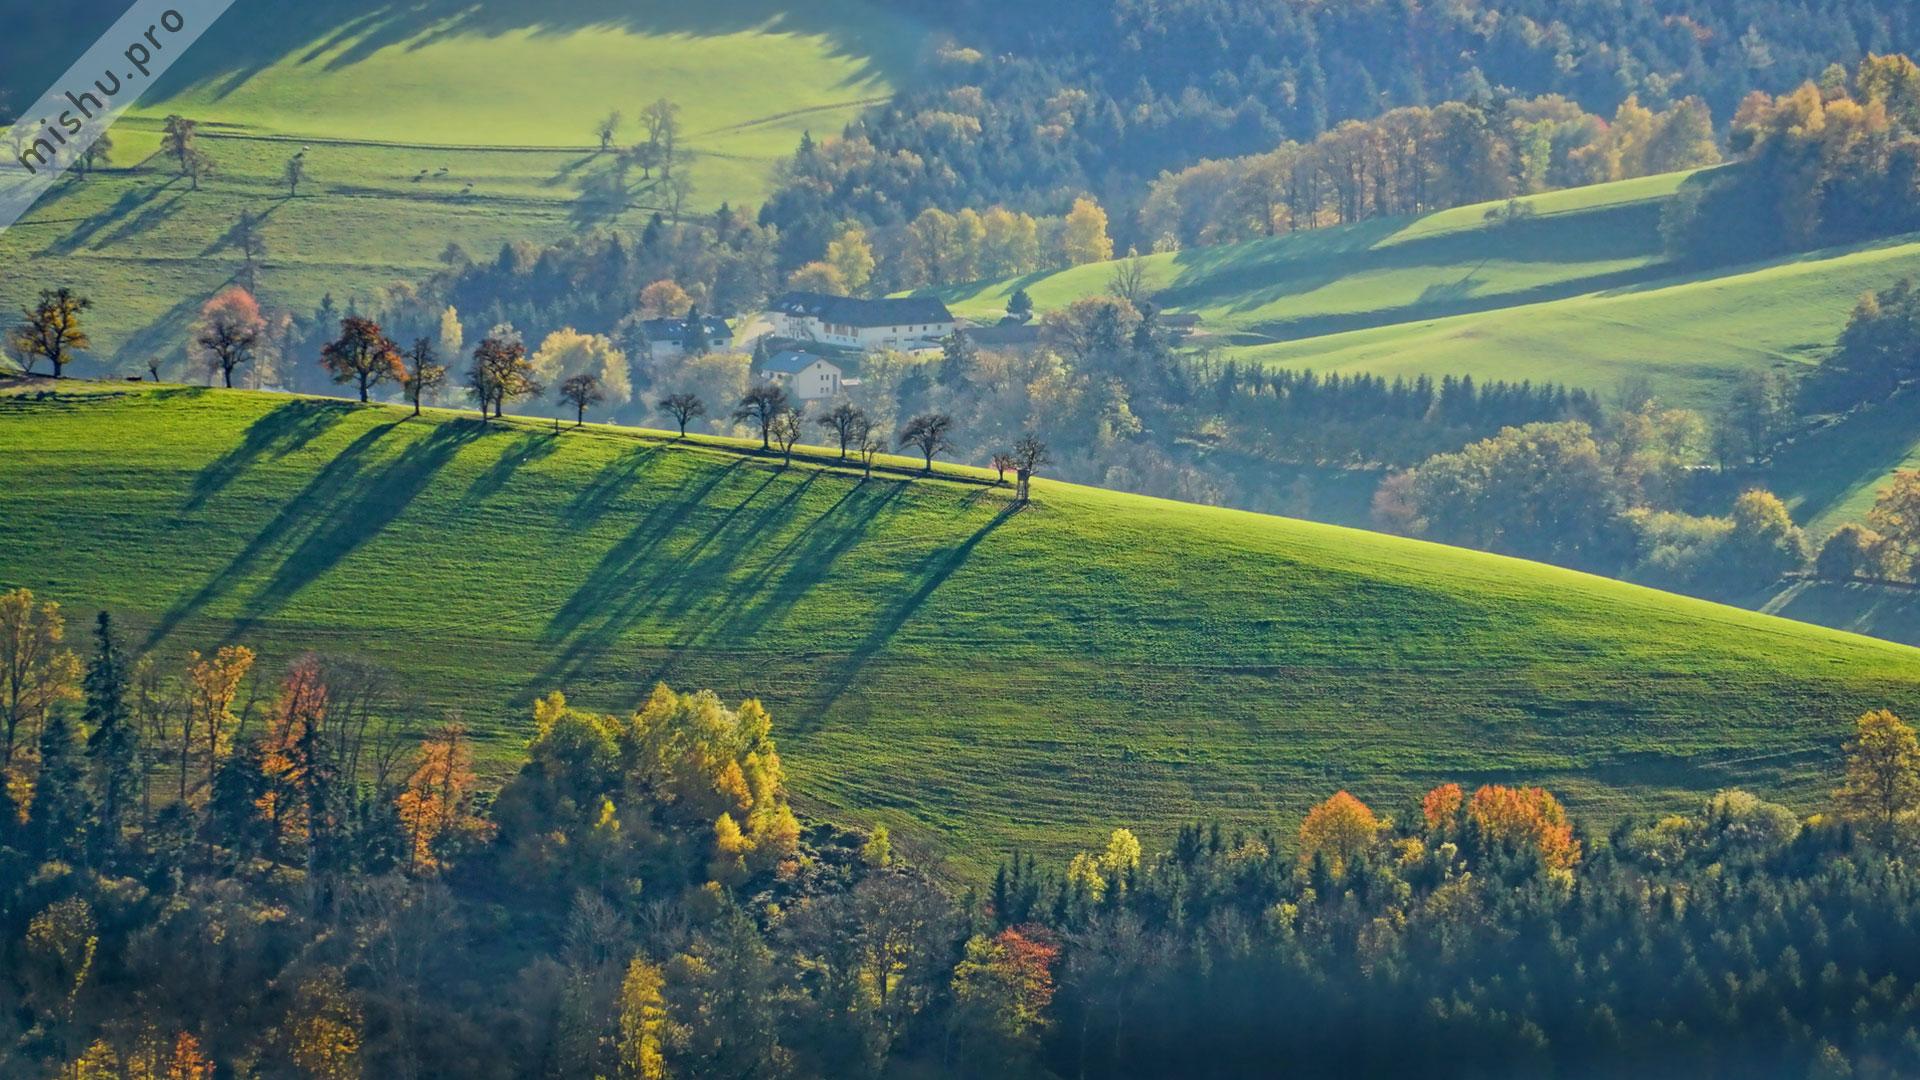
[941, 175, 1920, 536]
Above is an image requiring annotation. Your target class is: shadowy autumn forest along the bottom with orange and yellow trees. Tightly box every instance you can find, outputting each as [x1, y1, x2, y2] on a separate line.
[11, 590, 1920, 1080]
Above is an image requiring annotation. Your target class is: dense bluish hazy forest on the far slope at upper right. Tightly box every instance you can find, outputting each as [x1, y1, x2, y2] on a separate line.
[762, 0, 1920, 265]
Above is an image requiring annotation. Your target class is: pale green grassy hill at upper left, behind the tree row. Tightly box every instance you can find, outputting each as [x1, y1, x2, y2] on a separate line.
[0, 0, 924, 369]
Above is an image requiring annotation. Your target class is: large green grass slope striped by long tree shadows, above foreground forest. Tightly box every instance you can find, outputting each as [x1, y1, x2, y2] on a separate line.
[0, 382, 1920, 874]
